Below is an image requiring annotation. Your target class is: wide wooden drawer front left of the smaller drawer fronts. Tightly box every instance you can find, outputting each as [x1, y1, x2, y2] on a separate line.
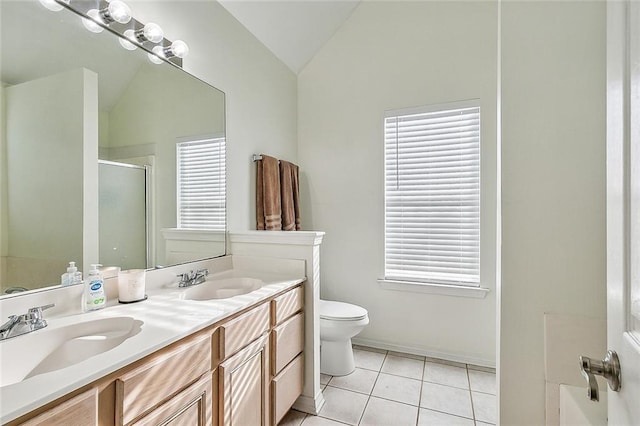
[116, 335, 211, 425]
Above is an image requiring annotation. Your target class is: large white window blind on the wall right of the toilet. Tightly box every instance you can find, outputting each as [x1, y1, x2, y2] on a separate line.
[385, 102, 480, 286]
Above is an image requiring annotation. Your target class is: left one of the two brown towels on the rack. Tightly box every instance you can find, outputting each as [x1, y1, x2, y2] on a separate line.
[256, 155, 282, 231]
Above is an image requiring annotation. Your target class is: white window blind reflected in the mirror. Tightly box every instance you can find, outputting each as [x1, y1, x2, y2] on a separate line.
[176, 138, 226, 231]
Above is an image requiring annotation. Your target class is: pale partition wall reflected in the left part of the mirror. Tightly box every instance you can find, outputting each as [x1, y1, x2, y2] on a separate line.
[4, 69, 98, 287]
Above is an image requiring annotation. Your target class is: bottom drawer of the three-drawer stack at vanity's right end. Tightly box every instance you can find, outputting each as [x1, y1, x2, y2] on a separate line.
[271, 354, 304, 424]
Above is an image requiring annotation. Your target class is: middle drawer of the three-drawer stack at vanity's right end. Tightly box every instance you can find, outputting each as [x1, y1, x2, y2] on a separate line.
[271, 313, 304, 376]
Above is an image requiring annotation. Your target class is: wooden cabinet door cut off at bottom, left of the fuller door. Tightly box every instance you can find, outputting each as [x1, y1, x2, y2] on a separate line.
[132, 373, 212, 426]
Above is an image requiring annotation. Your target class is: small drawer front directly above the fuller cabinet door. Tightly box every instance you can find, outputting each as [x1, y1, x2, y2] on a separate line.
[220, 303, 269, 359]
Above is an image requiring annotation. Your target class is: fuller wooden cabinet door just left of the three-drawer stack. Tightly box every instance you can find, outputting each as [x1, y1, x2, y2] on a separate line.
[219, 334, 269, 426]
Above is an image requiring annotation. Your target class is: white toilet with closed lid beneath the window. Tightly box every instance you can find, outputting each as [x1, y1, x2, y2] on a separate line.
[319, 300, 369, 376]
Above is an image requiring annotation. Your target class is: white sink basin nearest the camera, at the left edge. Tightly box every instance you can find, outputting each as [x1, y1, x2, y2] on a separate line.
[0, 317, 143, 387]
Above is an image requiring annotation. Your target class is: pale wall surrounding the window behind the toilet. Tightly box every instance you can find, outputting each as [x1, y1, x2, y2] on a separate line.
[298, 1, 498, 365]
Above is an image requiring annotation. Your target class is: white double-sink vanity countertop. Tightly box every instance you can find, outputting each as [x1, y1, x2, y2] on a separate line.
[0, 258, 305, 423]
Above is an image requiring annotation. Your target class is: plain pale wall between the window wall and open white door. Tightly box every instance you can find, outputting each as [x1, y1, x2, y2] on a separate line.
[500, 1, 606, 425]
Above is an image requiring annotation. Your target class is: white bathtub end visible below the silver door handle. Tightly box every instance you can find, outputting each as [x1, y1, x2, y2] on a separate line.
[560, 385, 607, 426]
